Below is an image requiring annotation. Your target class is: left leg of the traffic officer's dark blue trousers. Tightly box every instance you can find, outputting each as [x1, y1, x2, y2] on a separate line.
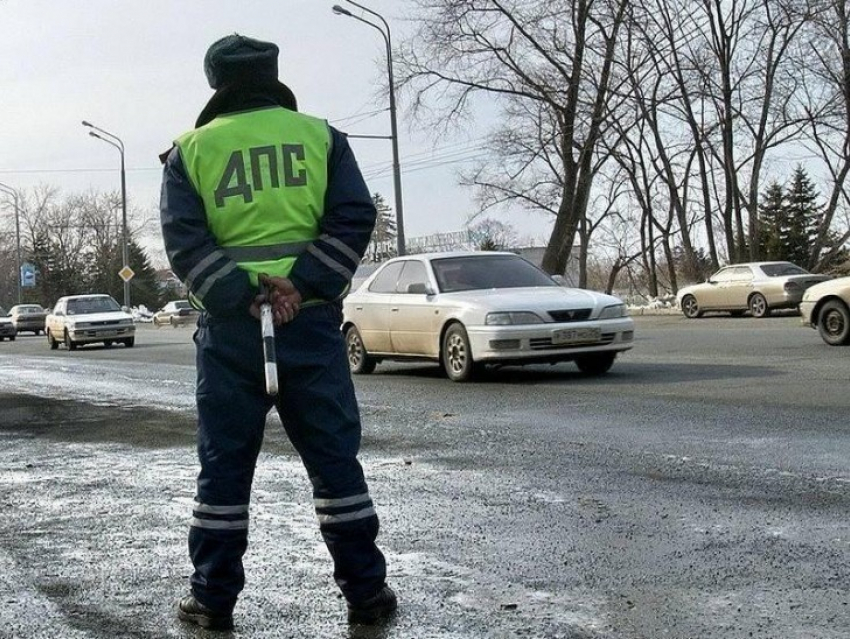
[189, 320, 271, 610]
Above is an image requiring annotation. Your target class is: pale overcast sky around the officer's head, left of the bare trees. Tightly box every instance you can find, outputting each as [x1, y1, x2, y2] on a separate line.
[0, 0, 548, 262]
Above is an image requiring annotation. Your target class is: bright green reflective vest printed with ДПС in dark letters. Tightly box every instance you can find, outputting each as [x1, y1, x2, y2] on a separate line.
[175, 107, 331, 285]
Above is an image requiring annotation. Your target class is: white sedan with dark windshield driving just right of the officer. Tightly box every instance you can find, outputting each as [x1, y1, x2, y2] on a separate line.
[342, 251, 634, 381]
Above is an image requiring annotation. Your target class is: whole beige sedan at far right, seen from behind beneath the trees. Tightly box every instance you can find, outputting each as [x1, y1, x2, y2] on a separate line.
[676, 262, 829, 318]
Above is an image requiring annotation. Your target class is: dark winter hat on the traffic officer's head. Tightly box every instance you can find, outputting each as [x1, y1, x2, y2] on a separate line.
[204, 33, 280, 90]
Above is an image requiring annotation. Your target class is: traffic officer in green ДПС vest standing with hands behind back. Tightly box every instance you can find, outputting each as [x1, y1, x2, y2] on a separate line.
[161, 35, 396, 629]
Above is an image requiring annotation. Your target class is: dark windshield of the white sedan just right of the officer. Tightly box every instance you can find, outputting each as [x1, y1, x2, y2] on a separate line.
[431, 255, 558, 293]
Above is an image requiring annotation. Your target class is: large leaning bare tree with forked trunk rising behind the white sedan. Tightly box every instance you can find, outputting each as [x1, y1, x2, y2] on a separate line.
[397, 0, 629, 280]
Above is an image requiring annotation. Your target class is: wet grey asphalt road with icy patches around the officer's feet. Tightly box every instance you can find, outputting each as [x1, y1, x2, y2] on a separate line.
[0, 316, 850, 639]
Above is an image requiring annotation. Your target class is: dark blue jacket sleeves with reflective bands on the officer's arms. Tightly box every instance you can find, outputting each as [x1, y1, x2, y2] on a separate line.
[160, 110, 377, 316]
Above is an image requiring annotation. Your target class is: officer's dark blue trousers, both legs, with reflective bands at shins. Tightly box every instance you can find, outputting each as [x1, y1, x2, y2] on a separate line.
[189, 304, 386, 610]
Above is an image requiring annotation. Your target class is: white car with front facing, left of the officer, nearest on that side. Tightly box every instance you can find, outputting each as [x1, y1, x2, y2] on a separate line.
[45, 295, 136, 351]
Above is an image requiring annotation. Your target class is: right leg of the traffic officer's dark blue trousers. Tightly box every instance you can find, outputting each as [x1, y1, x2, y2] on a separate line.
[277, 304, 386, 601]
